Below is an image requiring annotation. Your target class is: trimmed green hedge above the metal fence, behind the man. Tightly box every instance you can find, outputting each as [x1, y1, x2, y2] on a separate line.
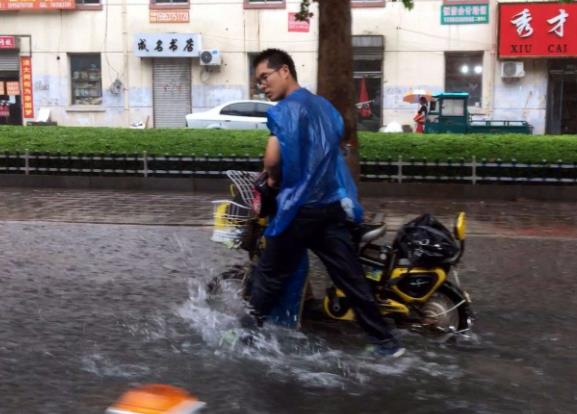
[0, 126, 577, 162]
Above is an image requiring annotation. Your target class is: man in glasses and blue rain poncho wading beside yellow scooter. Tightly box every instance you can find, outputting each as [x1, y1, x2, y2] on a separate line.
[241, 49, 405, 357]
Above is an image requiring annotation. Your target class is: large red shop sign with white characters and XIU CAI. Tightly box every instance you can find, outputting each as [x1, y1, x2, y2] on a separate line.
[499, 3, 577, 58]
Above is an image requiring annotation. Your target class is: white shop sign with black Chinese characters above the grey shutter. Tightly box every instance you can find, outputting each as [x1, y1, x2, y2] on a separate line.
[132, 33, 202, 57]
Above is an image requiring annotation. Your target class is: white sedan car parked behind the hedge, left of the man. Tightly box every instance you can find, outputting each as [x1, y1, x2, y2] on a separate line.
[186, 100, 276, 129]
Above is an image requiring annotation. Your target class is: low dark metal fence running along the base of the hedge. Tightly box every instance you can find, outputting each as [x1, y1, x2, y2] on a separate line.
[0, 152, 577, 184]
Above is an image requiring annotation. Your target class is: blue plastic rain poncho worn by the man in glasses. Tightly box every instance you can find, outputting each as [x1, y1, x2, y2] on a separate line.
[265, 88, 363, 237]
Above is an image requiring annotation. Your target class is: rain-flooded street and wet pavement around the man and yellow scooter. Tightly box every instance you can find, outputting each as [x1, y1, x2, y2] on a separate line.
[0, 189, 577, 414]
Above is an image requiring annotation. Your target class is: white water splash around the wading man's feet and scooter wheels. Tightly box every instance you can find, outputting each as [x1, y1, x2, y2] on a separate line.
[177, 268, 462, 390]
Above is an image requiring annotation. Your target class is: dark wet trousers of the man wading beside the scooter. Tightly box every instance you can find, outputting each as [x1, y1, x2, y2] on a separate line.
[250, 203, 394, 341]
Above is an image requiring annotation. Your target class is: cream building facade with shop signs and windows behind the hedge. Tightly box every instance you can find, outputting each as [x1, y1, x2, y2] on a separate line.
[0, 0, 577, 133]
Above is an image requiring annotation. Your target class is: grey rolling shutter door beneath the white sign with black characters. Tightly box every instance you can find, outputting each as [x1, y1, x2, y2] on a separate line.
[152, 59, 192, 128]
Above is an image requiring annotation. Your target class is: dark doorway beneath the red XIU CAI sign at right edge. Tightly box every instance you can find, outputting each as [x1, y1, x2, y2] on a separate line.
[547, 59, 577, 134]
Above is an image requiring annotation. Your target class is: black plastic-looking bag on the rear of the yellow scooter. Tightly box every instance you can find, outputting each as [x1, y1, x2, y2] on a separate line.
[393, 214, 460, 267]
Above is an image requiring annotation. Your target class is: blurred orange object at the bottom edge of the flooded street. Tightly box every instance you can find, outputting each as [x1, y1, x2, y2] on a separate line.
[106, 384, 206, 414]
